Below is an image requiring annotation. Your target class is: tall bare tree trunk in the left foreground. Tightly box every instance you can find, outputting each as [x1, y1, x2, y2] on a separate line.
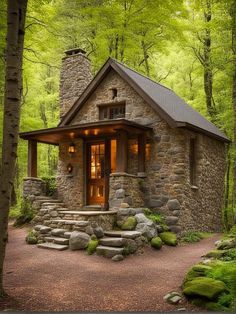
[0, 0, 27, 295]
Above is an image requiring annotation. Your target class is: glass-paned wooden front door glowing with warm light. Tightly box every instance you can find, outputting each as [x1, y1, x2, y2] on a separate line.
[87, 142, 108, 206]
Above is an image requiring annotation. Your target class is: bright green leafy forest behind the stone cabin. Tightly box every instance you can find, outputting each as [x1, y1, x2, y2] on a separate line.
[0, 0, 236, 228]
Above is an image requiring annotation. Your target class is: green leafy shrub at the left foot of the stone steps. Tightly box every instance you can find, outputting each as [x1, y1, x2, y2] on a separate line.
[14, 199, 36, 227]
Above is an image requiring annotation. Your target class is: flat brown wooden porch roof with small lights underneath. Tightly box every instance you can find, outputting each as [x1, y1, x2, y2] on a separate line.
[20, 119, 152, 145]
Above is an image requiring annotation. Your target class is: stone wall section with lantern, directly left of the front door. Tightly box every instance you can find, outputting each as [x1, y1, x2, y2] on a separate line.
[56, 139, 84, 210]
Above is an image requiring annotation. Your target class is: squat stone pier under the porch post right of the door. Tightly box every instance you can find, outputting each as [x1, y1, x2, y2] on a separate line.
[109, 173, 144, 208]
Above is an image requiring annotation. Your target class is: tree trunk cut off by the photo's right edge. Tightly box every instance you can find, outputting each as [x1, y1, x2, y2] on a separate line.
[230, 0, 236, 213]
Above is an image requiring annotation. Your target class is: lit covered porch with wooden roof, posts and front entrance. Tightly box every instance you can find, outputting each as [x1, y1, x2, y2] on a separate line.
[20, 119, 152, 209]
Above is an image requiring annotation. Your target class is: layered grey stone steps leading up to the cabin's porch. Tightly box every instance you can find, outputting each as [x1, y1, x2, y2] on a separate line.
[30, 196, 142, 258]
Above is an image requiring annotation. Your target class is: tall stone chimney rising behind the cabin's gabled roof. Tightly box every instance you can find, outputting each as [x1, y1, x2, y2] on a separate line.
[60, 48, 92, 118]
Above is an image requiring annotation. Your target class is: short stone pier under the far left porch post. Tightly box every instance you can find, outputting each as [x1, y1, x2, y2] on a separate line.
[23, 178, 46, 202]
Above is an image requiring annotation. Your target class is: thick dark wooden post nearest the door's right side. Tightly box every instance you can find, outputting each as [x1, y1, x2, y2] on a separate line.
[116, 130, 128, 172]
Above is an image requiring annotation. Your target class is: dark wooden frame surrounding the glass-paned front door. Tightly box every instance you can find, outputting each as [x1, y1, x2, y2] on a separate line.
[84, 137, 112, 210]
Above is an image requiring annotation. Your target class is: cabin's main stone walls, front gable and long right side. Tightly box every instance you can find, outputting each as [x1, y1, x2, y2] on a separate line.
[59, 71, 225, 232]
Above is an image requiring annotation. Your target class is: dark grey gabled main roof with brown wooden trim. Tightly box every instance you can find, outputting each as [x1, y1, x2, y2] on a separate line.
[59, 58, 229, 142]
